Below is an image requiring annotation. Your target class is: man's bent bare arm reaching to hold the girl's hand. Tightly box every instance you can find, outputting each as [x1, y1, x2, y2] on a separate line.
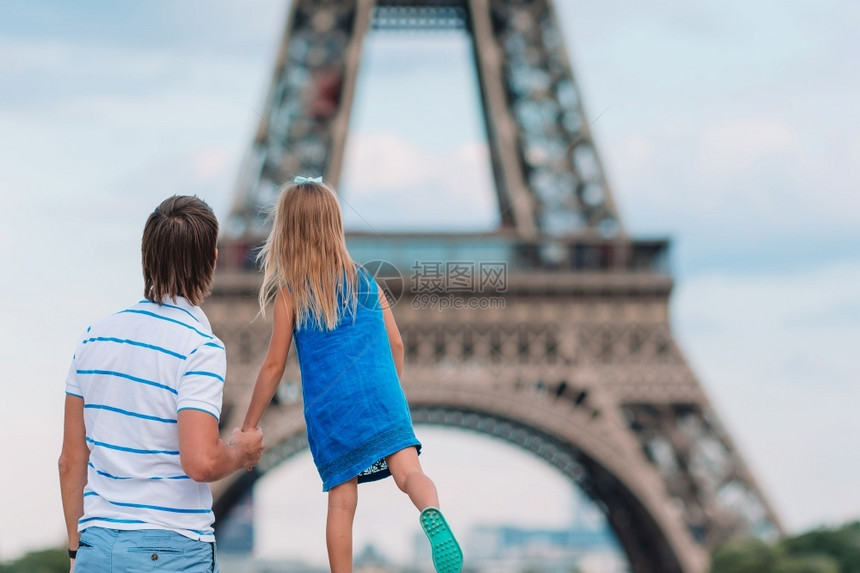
[177, 410, 263, 482]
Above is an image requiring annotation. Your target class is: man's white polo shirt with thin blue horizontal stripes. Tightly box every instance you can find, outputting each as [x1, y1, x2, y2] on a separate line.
[66, 298, 227, 541]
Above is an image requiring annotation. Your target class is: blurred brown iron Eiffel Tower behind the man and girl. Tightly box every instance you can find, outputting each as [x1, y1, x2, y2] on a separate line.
[206, 0, 781, 573]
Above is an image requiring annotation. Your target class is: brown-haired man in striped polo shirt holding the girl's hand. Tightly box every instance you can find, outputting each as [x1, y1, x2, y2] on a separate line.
[59, 196, 263, 573]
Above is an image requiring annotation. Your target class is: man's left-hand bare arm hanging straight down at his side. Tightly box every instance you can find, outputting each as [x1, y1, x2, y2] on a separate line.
[58, 394, 90, 560]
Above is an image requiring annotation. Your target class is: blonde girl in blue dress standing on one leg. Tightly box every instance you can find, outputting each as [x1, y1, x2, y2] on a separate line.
[244, 177, 463, 573]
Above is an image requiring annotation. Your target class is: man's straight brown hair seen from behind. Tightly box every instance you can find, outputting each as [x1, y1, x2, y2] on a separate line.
[141, 195, 218, 305]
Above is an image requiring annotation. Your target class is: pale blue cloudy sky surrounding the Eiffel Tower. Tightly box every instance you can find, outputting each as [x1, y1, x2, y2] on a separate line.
[0, 0, 860, 559]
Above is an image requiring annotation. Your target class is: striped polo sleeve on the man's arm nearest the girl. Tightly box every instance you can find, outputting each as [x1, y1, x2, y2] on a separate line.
[176, 342, 227, 420]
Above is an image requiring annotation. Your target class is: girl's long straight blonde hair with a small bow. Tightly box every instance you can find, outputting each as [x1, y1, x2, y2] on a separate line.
[257, 182, 358, 330]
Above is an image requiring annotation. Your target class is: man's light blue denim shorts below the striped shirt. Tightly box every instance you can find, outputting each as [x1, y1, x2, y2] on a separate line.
[75, 527, 218, 573]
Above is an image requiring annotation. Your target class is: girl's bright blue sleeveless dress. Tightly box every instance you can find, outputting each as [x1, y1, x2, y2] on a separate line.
[293, 267, 421, 491]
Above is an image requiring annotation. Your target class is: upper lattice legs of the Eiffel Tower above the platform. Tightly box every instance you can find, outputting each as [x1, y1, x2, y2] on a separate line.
[228, 0, 622, 244]
